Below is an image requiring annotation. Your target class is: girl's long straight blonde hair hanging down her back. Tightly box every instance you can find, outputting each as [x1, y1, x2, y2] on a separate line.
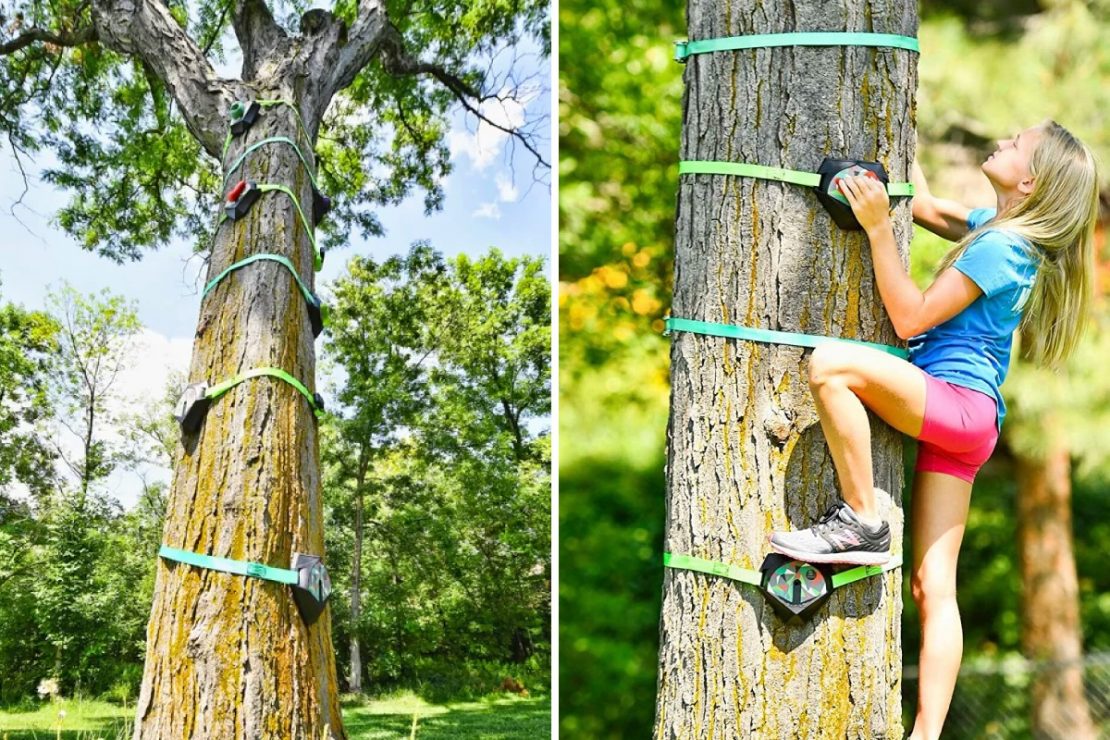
[937, 121, 1099, 368]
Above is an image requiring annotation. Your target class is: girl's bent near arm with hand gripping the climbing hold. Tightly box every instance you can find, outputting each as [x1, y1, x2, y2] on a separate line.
[840, 178, 982, 339]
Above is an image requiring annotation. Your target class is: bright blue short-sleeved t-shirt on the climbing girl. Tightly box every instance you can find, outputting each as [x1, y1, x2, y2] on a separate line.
[909, 209, 1038, 432]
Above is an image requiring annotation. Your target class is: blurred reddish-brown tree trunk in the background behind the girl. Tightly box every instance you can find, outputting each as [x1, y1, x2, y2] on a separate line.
[1017, 420, 1097, 740]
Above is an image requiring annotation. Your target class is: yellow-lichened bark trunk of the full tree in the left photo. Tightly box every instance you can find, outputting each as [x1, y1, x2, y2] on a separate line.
[134, 94, 345, 740]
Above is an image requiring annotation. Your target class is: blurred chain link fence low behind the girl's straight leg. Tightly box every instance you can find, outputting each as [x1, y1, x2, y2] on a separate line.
[902, 652, 1110, 740]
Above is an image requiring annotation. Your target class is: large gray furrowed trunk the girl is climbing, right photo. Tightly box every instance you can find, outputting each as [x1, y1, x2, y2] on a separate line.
[655, 0, 917, 739]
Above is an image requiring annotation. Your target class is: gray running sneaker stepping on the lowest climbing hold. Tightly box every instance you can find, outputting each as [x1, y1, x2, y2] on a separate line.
[770, 501, 890, 565]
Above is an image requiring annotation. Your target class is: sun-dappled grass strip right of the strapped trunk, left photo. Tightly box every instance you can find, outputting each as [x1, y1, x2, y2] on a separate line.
[343, 697, 551, 740]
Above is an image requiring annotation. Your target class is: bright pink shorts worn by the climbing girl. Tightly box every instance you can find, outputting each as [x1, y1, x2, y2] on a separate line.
[914, 371, 998, 483]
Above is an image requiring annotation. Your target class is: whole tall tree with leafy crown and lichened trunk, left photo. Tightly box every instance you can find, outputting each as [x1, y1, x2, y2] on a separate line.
[0, 0, 546, 738]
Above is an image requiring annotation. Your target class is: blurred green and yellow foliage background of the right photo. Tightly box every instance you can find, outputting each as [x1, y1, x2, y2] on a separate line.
[558, 0, 1110, 738]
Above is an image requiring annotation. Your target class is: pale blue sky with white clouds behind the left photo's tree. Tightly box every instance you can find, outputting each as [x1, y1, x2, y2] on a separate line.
[0, 28, 553, 506]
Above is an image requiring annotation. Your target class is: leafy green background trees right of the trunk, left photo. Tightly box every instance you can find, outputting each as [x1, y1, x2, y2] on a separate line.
[325, 244, 551, 698]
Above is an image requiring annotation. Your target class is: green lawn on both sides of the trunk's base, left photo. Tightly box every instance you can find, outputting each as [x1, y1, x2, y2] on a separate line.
[0, 693, 551, 740]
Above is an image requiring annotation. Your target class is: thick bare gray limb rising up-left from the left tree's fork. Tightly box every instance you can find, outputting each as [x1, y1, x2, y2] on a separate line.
[92, 0, 235, 158]
